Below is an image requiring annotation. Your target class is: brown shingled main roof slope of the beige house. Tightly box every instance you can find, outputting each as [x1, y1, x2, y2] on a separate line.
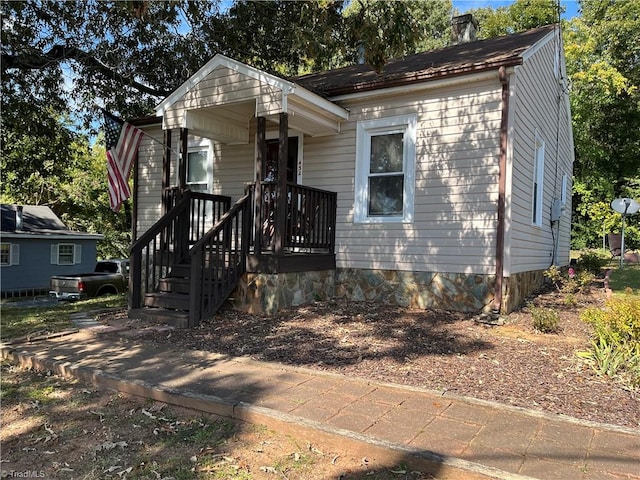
[292, 25, 557, 97]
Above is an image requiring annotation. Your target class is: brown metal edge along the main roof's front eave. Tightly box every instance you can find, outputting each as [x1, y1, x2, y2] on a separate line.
[322, 56, 523, 98]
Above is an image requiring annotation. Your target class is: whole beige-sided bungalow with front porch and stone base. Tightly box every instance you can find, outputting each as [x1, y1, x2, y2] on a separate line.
[130, 21, 574, 325]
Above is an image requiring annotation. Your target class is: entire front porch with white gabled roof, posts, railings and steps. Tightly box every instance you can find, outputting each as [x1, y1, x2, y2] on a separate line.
[130, 55, 348, 326]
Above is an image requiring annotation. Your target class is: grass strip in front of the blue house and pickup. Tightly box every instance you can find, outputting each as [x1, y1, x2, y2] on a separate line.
[0, 294, 127, 342]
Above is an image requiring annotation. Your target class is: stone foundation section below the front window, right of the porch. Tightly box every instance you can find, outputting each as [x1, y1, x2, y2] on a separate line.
[335, 269, 494, 312]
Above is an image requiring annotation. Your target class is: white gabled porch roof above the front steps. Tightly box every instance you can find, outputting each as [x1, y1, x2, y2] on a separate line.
[156, 54, 349, 144]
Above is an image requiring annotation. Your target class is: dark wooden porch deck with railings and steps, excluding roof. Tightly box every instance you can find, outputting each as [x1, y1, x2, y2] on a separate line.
[129, 178, 336, 327]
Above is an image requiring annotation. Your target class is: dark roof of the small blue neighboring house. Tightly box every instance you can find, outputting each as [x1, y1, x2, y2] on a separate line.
[0, 204, 104, 240]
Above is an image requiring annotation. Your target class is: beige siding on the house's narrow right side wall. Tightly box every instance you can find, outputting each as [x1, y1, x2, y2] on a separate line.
[505, 37, 573, 275]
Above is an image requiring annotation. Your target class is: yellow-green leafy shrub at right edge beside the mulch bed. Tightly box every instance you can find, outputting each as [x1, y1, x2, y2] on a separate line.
[579, 296, 640, 389]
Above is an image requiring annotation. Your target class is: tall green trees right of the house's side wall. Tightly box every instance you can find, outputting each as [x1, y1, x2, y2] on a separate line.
[564, 0, 640, 247]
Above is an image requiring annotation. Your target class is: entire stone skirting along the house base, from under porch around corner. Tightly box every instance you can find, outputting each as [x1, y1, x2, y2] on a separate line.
[227, 268, 544, 315]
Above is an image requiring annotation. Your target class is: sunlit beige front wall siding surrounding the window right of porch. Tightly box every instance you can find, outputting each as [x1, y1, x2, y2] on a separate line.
[303, 81, 500, 274]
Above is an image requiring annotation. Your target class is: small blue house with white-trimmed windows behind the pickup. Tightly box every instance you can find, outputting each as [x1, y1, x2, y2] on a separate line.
[0, 204, 103, 297]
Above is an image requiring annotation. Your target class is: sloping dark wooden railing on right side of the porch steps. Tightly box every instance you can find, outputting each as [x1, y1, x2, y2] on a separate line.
[189, 195, 252, 326]
